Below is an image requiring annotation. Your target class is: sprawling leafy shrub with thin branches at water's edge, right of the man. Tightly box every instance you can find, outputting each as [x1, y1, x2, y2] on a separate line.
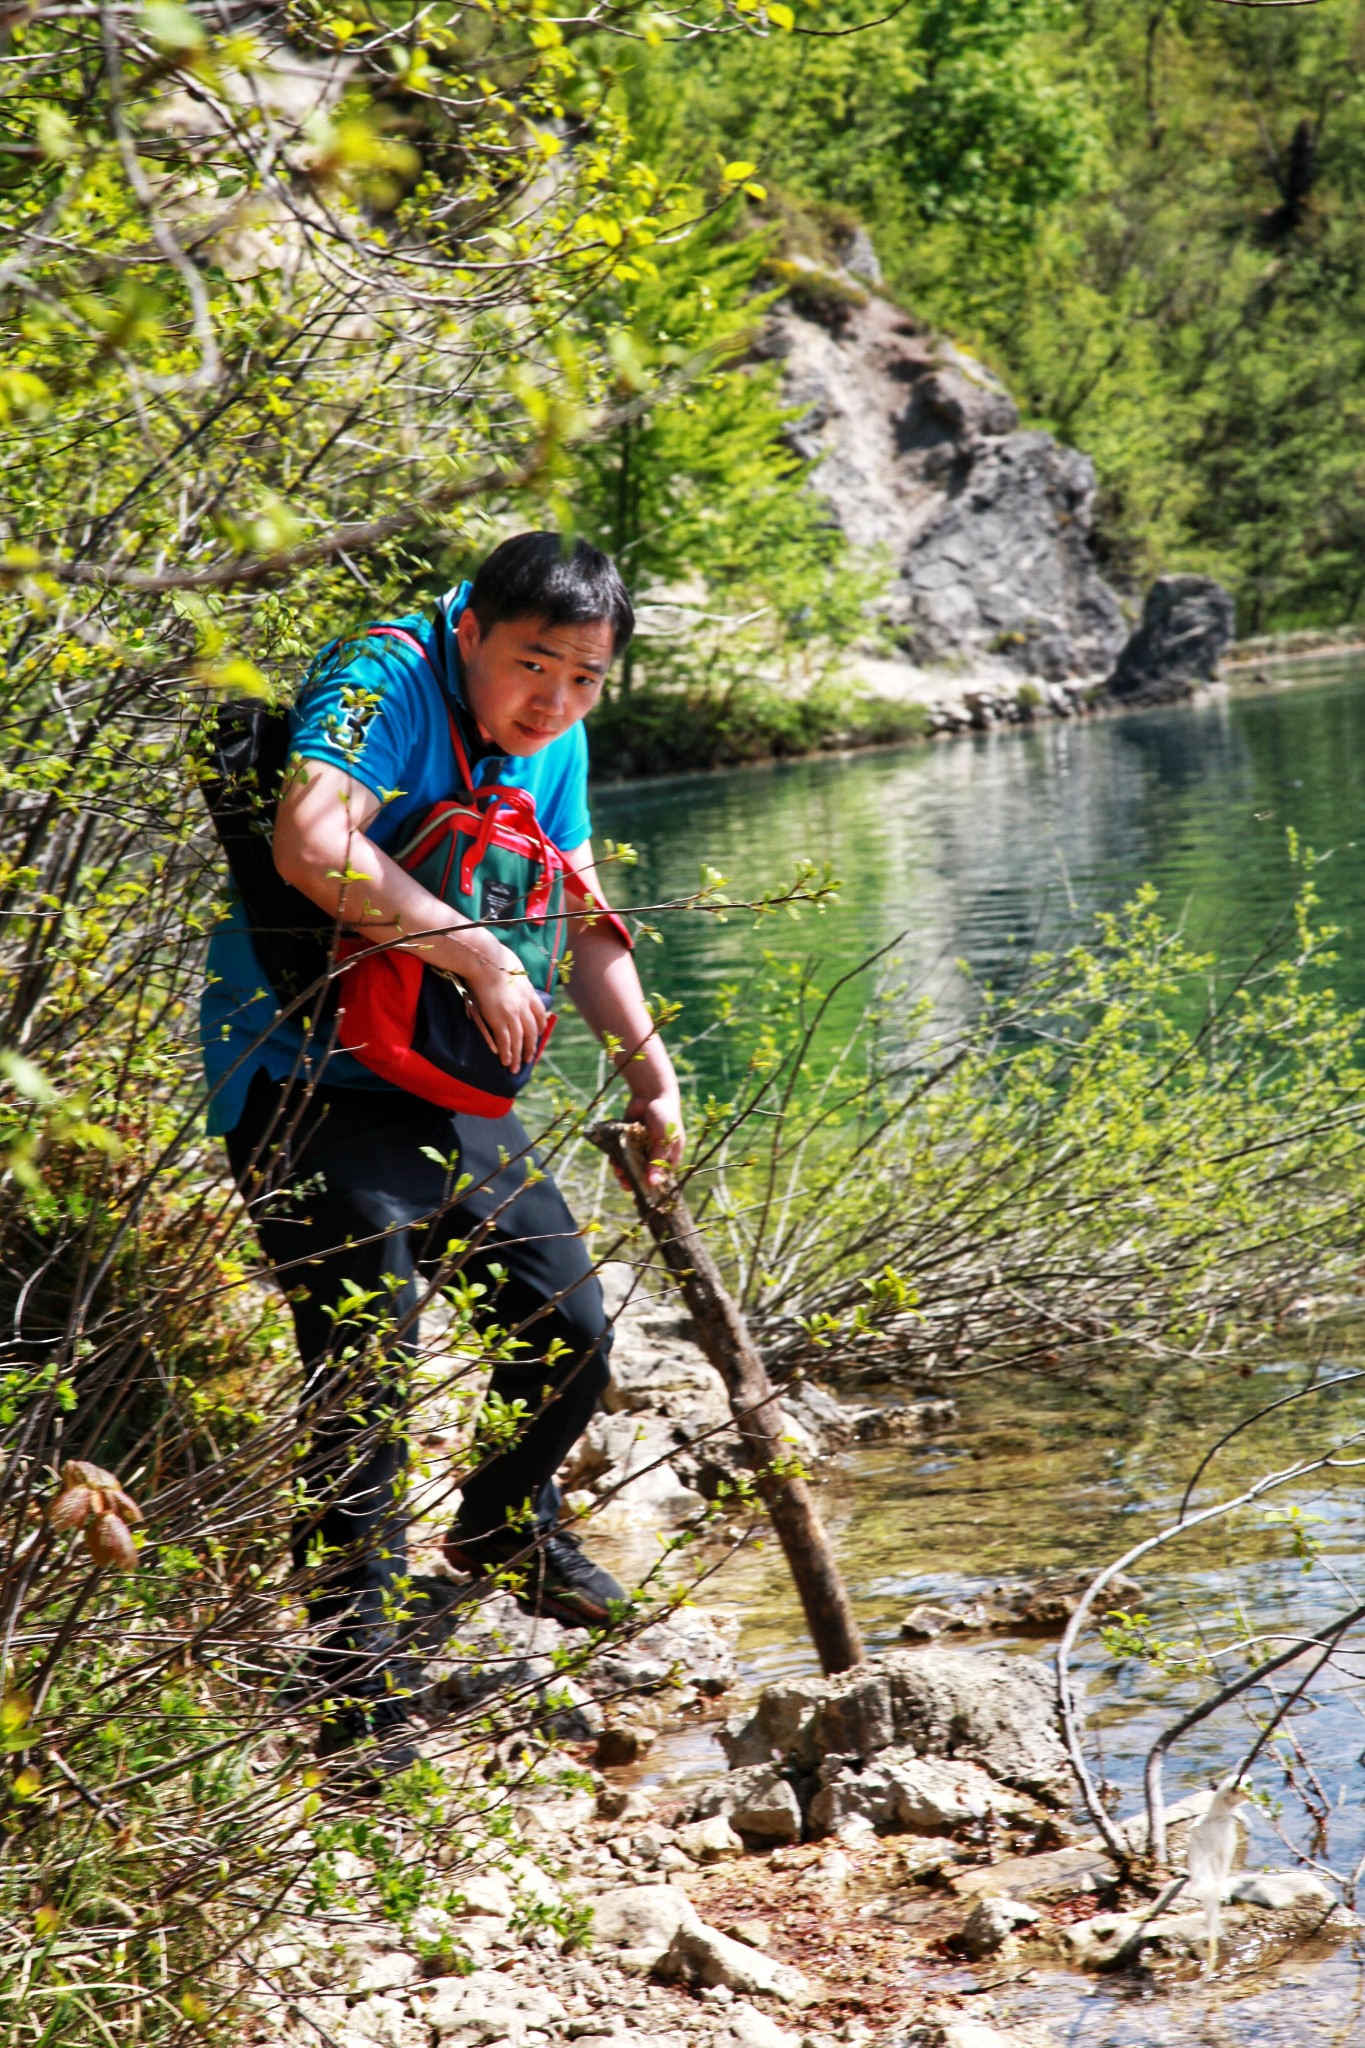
[654, 856, 1365, 1386]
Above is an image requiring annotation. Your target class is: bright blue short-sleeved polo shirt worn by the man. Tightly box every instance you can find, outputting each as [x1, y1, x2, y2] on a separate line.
[199, 584, 591, 1133]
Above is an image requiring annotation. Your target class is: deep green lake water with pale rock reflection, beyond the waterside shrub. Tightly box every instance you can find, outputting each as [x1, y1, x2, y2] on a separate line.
[593, 664, 1365, 1081]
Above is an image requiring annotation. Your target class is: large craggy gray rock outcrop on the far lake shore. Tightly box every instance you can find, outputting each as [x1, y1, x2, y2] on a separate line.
[767, 272, 1128, 680]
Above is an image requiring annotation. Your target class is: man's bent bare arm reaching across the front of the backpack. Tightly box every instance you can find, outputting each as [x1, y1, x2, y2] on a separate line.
[274, 760, 544, 1069]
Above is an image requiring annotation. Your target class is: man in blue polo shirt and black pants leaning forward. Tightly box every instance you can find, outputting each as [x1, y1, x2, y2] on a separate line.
[201, 532, 684, 1767]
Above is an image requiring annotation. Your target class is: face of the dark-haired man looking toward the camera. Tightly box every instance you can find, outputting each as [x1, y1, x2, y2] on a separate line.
[456, 604, 612, 754]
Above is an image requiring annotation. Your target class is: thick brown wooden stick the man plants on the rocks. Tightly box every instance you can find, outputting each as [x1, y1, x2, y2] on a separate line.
[587, 1124, 866, 1675]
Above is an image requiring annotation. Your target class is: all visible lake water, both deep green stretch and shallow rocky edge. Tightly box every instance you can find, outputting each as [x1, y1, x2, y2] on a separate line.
[593, 666, 1365, 2048]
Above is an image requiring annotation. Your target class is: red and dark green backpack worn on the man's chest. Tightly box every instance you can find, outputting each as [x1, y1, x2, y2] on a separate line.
[338, 627, 632, 1116]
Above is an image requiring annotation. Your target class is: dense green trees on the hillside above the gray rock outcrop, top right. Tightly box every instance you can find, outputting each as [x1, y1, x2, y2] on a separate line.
[609, 0, 1365, 633]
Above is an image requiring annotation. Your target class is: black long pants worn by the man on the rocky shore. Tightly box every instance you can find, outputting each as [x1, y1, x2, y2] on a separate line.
[227, 1075, 612, 1649]
